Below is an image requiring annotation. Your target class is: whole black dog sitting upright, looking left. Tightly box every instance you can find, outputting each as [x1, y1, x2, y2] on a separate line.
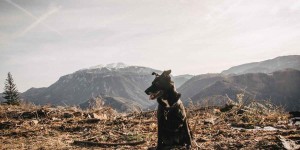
[145, 70, 191, 149]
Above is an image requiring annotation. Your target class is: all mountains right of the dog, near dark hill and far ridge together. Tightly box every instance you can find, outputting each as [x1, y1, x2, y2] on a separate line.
[178, 55, 300, 111]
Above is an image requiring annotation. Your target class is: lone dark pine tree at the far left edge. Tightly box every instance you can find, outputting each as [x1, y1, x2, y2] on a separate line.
[3, 72, 20, 105]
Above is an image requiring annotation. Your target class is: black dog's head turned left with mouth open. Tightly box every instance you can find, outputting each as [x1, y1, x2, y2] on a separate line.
[145, 70, 174, 100]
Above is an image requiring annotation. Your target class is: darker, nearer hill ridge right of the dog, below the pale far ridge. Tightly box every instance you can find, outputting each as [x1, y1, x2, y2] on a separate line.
[178, 69, 300, 110]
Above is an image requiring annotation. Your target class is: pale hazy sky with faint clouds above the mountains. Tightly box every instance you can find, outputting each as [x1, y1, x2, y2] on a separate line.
[0, 0, 300, 92]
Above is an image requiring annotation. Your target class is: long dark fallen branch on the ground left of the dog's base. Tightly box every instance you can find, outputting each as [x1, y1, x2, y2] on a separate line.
[73, 141, 146, 147]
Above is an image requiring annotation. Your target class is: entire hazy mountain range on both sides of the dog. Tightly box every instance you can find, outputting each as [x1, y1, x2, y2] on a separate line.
[1, 55, 300, 111]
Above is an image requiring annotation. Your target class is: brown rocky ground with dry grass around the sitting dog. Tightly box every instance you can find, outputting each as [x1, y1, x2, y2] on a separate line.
[0, 99, 300, 149]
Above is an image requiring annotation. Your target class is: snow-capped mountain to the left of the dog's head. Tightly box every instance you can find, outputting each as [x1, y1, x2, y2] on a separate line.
[22, 63, 160, 108]
